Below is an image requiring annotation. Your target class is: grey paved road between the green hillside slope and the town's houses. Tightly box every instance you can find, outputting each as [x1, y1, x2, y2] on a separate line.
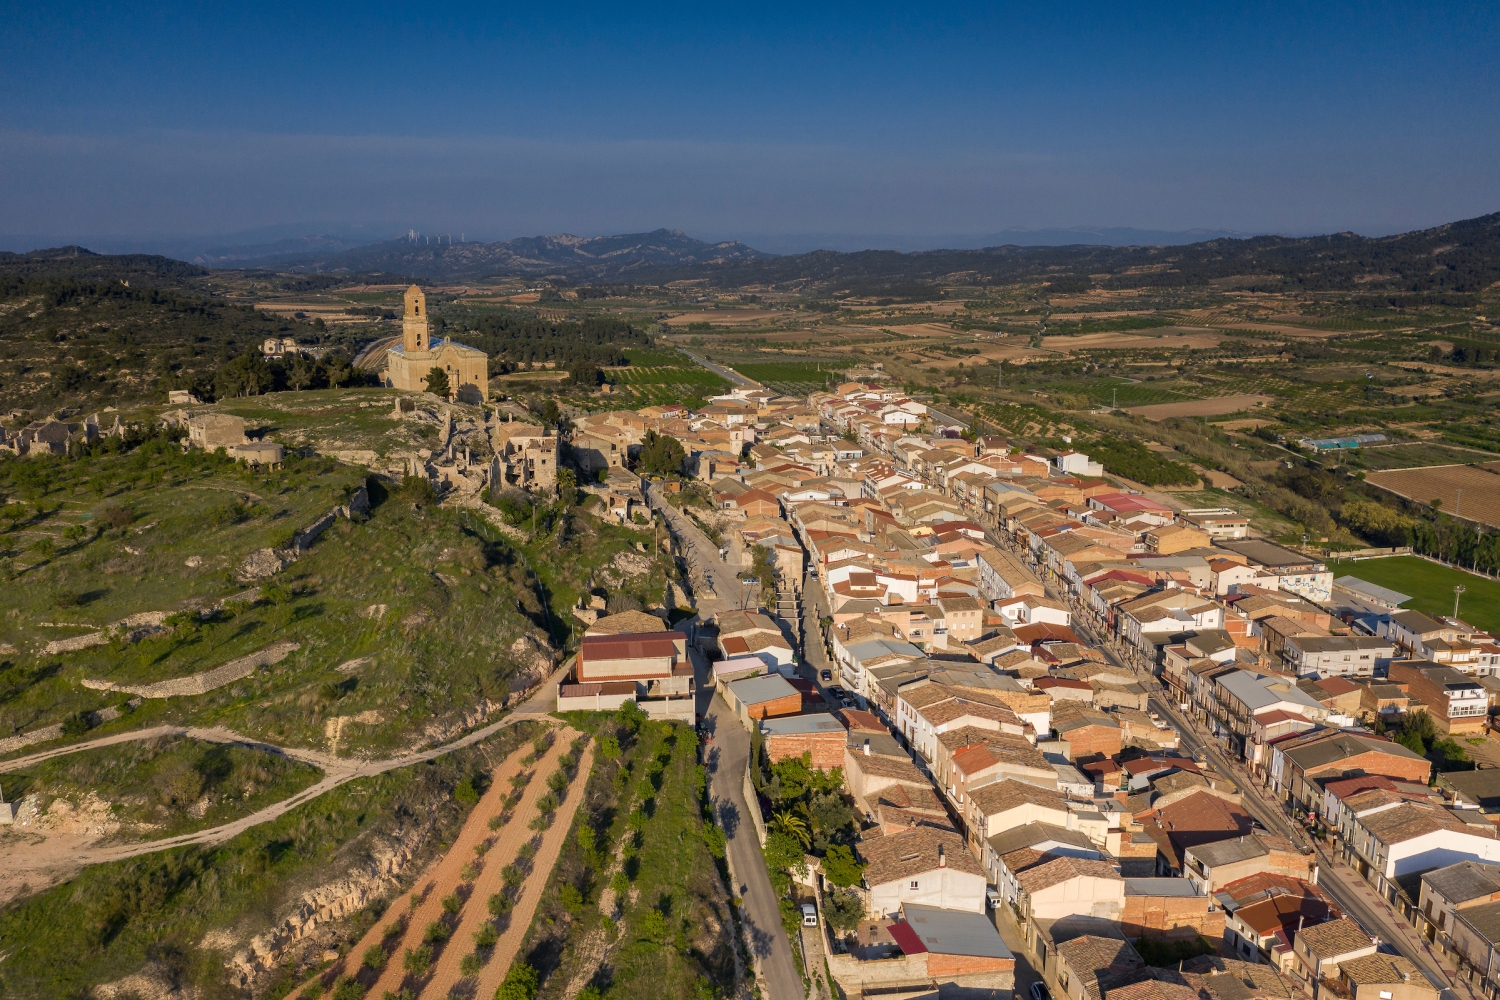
[647, 484, 806, 1000]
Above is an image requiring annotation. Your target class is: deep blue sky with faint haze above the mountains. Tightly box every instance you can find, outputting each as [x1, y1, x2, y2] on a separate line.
[0, 1, 1500, 241]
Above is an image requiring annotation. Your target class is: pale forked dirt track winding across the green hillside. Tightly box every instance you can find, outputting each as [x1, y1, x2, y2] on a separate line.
[0, 664, 567, 897]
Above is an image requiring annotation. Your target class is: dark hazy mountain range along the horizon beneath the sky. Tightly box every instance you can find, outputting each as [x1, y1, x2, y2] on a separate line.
[11, 206, 1500, 298]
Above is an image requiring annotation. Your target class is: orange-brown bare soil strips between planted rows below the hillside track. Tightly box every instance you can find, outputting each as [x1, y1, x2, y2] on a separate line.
[301, 727, 594, 999]
